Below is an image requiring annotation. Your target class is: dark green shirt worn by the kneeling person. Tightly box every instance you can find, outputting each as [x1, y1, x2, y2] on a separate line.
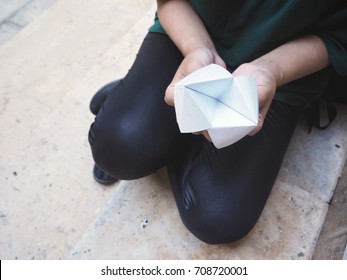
[149, 0, 347, 104]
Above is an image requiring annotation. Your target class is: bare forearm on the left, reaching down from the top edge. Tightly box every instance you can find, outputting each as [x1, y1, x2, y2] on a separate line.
[157, 0, 215, 56]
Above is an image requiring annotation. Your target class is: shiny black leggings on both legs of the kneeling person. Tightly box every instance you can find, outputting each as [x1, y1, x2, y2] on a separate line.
[89, 33, 298, 243]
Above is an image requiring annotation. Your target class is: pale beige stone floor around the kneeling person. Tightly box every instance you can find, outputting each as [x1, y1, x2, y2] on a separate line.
[0, 0, 347, 259]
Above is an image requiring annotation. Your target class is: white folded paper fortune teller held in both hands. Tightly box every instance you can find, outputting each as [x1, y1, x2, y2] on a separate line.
[174, 64, 259, 148]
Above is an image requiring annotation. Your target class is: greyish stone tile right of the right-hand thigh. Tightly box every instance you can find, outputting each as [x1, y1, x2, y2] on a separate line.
[279, 106, 347, 203]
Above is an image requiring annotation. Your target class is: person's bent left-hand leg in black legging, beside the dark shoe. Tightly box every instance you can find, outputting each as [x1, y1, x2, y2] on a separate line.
[89, 33, 183, 179]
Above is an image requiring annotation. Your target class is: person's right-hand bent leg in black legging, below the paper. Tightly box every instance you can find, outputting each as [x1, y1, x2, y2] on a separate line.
[169, 102, 297, 244]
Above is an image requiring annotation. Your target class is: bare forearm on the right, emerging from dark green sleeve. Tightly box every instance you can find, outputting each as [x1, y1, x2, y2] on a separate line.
[251, 35, 329, 86]
